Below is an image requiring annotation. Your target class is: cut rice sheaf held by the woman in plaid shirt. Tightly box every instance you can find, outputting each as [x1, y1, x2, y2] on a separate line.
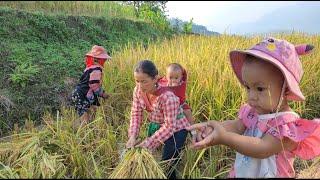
[109, 148, 166, 179]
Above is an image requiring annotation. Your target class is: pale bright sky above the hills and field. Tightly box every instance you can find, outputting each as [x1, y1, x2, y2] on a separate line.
[166, 1, 299, 33]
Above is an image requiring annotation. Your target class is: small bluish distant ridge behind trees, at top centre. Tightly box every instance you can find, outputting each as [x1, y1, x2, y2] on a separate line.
[169, 18, 220, 36]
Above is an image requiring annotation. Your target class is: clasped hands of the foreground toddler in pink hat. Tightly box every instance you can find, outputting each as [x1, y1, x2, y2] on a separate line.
[186, 120, 226, 149]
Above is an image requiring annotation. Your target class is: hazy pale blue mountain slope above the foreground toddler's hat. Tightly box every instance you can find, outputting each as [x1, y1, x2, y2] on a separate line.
[230, 1, 320, 34]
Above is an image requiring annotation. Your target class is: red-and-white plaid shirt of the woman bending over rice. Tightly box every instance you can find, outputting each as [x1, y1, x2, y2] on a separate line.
[128, 87, 190, 150]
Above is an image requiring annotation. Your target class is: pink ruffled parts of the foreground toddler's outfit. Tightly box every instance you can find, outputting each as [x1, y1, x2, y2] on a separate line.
[229, 104, 320, 178]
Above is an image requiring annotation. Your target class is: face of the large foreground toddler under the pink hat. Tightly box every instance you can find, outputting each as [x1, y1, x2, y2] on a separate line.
[242, 57, 284, 114]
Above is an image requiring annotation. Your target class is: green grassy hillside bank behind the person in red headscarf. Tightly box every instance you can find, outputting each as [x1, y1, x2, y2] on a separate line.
[0, 8, 170, 135]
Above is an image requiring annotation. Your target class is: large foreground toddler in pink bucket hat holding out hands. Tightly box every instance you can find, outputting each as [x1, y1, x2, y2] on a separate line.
[187, 38, 320, 178]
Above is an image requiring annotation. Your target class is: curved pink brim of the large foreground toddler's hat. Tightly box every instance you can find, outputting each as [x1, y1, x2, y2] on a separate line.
[229, 49, 305, 101]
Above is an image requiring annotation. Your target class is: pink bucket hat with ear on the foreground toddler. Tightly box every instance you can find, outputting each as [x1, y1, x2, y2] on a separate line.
[230, 37, 314, 101]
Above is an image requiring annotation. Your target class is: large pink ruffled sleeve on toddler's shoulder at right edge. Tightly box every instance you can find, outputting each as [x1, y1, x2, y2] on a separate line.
[266, 117, 320, 159]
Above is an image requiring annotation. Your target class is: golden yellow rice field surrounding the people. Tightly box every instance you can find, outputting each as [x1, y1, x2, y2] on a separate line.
[0, 33, 320, 178]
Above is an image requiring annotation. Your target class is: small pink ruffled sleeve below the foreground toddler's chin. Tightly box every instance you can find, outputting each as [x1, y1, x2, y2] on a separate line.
[238, 104, 258, 128]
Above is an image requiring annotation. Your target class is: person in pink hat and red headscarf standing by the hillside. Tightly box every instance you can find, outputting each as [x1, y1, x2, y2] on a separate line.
[72, 45, 111, 127]
